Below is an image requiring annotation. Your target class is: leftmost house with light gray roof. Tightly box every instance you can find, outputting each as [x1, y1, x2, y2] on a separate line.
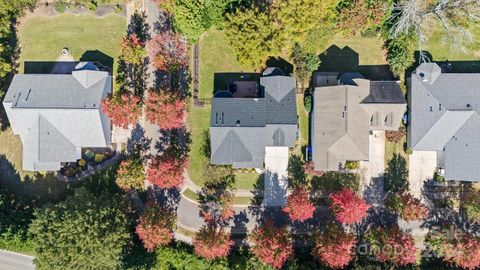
[3, 62, 112, 171]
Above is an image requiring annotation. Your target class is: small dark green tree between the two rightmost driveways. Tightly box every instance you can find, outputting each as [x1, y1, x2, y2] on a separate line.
[384, 154, 408, 192]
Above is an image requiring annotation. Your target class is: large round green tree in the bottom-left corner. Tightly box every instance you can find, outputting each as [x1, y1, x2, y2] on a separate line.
[30, 188, 130, 270]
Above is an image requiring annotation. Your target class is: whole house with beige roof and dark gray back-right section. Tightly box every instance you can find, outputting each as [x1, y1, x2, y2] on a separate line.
[311, 72, 406, 171]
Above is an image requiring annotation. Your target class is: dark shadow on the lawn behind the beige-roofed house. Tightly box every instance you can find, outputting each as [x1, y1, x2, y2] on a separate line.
[318, 45, 395, 81]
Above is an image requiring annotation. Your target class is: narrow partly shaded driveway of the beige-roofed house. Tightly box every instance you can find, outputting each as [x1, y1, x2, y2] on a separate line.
[360, 130, 385, 204]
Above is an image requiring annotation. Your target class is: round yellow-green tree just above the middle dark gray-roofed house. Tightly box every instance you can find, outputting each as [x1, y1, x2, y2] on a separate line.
[225, 8, 283, 69]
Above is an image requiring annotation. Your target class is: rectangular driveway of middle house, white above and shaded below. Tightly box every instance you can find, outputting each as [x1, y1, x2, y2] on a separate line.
[263, 147, 288, 206]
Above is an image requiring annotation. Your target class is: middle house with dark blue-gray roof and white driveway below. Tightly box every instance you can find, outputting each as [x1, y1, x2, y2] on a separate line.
[210, 68, 297, 168]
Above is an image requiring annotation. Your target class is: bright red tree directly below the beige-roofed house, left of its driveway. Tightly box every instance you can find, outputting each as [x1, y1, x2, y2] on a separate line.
[330, 188, 370, 224]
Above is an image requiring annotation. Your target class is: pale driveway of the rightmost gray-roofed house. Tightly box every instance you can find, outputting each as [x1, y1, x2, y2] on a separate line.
[408, 151, 437, 198]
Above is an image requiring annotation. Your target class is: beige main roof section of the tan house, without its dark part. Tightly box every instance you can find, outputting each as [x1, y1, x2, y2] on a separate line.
[313, 84, 369, 171]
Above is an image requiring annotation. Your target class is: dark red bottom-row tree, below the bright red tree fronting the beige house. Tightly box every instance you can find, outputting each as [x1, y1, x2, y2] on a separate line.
[312, 225, 357, 269]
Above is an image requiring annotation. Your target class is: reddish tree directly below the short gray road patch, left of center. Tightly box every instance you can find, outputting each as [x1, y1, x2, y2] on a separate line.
[193, 226, 234, 260]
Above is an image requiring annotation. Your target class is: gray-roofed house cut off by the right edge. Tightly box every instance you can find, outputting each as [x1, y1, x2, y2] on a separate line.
[408, 63, 480, 181]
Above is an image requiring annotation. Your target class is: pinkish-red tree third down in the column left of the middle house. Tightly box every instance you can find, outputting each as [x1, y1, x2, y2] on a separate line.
[147, 155, 188, 188]
